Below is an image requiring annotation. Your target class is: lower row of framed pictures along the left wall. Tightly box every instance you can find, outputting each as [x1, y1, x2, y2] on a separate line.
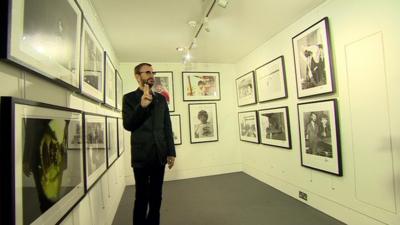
[0, 97, 124, 225]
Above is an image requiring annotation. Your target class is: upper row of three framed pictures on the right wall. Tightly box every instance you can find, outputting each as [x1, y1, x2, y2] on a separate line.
[236, 17, 335, 106]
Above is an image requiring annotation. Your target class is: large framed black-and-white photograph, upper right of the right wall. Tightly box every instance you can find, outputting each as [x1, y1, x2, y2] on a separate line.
[292, 17, 335, 98]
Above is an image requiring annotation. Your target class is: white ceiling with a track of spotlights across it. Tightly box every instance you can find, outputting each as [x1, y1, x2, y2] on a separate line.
[91, 0, 325, 63]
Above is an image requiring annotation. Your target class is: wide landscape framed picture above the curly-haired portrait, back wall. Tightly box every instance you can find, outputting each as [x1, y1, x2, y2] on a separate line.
[182, 72, 221, 101]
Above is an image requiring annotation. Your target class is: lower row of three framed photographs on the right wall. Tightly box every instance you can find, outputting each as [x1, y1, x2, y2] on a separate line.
[238, 99, 342, 176]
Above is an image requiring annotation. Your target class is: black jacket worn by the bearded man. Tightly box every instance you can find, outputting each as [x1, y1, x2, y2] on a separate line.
[122, 88, 176, 167]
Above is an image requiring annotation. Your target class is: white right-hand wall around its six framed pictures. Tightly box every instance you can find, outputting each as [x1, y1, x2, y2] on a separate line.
[236, 0, 400, 225]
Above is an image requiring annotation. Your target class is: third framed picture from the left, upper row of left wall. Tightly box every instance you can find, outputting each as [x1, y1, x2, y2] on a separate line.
[104, 52, 117, 108]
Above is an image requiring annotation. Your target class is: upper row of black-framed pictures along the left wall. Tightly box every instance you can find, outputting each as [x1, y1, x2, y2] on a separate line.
[0, 0, 123, 110]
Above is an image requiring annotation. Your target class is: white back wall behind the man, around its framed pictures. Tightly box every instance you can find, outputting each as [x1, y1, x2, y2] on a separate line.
[120, 62, 242, 184]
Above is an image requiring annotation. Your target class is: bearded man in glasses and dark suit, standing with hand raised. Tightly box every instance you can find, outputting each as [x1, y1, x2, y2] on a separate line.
[122, 63, 176, 225]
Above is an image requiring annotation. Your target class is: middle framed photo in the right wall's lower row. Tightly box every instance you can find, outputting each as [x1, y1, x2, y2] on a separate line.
[258, 106, 292, 149]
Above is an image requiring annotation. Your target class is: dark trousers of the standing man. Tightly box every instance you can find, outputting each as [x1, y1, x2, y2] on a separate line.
[133, 165, 165, 225]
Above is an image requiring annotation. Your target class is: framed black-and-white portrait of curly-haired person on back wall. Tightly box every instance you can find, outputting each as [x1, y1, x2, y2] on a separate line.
[188, 103, 218, 144]
